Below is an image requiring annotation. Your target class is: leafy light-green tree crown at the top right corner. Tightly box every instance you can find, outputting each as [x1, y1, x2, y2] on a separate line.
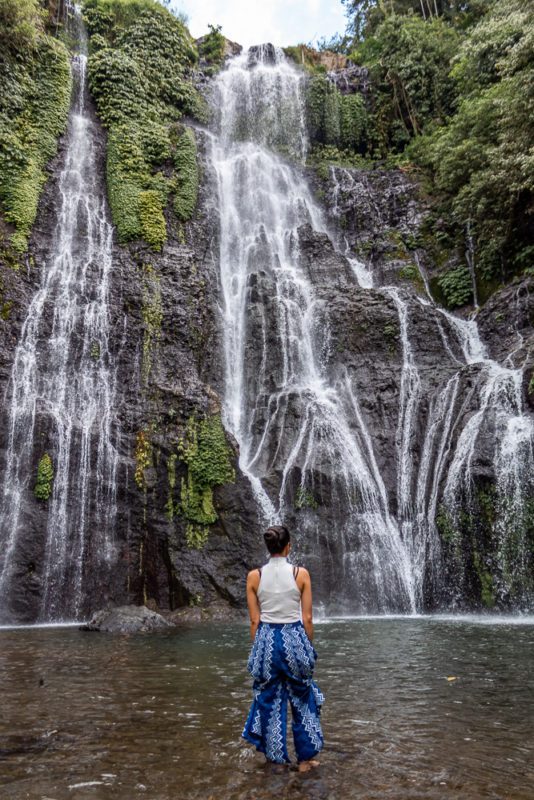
[409, 0, 534, 290]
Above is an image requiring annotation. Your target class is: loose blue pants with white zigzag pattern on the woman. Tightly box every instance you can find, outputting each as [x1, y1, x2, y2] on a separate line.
[243, 622, 324, 764]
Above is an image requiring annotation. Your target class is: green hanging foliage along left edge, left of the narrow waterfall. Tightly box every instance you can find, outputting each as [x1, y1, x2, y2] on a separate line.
[0, 19, 71, 252]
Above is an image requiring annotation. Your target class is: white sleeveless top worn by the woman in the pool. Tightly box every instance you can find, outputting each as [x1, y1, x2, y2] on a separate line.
[258, 556, 302, 623]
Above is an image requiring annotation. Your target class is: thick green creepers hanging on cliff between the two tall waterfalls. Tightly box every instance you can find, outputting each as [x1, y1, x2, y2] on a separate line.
[84, 0, 207, 250]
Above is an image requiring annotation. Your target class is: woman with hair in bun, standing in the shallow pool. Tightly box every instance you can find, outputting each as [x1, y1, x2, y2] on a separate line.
[243, 525, 324, 772]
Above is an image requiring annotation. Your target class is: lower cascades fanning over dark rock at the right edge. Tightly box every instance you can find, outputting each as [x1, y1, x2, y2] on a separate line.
[331, 168, 534, 608]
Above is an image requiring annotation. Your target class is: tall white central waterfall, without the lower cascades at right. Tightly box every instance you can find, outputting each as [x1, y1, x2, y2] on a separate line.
[212, 48, 415, 611]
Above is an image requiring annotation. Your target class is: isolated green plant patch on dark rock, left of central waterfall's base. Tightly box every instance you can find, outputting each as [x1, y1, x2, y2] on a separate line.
[179, 414, 235, 547]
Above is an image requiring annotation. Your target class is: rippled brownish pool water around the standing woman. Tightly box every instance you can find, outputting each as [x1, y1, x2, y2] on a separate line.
[0, 618, 534, 800]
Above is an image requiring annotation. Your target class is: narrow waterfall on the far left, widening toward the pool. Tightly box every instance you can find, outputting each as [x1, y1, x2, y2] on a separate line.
[0, 7, 118, 620]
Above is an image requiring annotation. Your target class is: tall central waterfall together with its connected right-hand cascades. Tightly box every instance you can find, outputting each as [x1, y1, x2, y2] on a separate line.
[212, 46, 534, 612]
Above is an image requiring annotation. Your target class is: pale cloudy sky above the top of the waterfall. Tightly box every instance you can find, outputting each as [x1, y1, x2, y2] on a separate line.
[171, 0, 346, 47]
